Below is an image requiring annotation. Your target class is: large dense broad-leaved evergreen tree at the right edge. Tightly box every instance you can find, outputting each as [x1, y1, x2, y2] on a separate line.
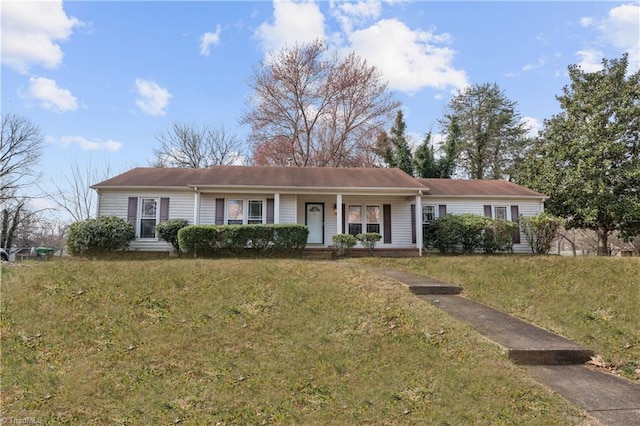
[519, 54, 640, 255]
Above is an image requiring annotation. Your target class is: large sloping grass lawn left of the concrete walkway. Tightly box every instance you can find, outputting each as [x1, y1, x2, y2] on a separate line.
[0, 259, 588, 425]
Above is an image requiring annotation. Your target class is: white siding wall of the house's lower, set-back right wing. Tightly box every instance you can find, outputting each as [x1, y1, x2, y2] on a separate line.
[422, 196, 544, 253]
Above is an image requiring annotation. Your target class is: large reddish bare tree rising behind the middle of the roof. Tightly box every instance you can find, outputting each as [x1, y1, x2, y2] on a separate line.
[241, 40, 400, 167]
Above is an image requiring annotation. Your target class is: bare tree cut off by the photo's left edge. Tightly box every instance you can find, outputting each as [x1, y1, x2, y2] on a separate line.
[0, 113, 43, 201]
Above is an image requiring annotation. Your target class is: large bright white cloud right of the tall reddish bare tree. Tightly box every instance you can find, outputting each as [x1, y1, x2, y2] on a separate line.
[348, 19, 468, 93]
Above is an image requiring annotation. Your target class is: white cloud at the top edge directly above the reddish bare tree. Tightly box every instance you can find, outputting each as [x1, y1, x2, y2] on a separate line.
[255, 0, 324, 52]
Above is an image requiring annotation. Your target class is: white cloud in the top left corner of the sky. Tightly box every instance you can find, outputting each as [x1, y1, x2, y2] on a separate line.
[0, 1, 83, 73]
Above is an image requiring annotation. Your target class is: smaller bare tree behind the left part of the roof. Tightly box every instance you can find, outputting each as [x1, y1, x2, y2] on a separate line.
[149, 123, 243, 169]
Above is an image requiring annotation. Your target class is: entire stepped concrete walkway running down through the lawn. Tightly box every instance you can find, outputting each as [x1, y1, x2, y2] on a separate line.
[374, 269, 640, 426]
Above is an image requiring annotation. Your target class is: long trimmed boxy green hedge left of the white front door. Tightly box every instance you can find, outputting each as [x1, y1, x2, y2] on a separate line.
[178, 225, 309, 257]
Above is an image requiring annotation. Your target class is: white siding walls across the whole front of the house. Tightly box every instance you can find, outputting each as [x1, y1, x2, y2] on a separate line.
[98, 189, 544, 253]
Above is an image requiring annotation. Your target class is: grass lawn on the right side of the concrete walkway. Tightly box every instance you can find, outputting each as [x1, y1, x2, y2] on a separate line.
[363, 255, 640, 383]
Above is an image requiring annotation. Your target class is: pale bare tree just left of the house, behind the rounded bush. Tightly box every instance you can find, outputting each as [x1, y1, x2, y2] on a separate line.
[46, 160, 111, 222]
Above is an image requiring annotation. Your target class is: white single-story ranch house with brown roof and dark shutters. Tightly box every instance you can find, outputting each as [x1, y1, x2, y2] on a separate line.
[92, 166, 546, 254]
